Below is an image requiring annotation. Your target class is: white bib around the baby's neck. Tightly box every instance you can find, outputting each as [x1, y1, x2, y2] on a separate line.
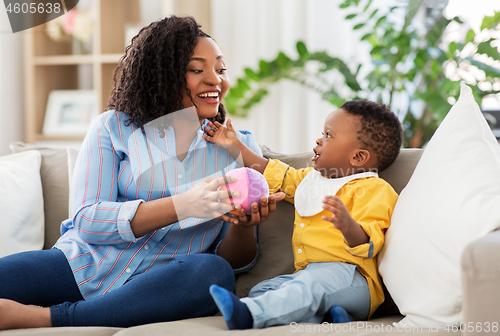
[294, 170, 378, 217]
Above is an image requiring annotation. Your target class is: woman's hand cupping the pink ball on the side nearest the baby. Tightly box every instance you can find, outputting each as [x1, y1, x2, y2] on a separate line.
[222, 192, 285, 227]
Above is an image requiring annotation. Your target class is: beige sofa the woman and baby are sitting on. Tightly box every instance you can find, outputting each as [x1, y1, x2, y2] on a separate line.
[0, 143, 500, 336]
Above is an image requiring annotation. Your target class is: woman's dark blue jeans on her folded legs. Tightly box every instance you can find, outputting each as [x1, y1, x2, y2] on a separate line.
[0, 249, 234, 327]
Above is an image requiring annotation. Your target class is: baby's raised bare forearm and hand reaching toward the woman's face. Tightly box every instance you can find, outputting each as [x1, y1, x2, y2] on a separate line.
[203, 119, 268, 174]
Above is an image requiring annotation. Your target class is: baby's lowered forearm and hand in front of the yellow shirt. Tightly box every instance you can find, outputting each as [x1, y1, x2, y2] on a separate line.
[321, 196, 370, 247]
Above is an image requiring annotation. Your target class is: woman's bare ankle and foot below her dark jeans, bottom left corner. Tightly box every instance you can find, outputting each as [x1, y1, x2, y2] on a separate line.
[0, 299, 52, 330]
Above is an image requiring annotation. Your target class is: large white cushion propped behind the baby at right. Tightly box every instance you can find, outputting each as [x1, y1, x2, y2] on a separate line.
[379, 84, 500, 327]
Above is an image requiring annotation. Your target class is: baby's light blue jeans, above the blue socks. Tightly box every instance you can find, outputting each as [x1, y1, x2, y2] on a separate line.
[241, 262, 370, 328]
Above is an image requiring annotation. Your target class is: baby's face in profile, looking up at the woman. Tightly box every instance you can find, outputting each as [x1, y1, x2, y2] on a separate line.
[312, 109, 361, 177]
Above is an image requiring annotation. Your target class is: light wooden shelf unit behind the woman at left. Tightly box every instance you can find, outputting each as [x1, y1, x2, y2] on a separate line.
[24, 0, 140, 143]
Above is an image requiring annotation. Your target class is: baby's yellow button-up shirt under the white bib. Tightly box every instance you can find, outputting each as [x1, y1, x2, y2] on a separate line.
[264, 160, 398, 316]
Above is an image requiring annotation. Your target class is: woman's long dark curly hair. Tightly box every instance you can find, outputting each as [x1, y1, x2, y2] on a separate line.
[106, 15, 226, 128]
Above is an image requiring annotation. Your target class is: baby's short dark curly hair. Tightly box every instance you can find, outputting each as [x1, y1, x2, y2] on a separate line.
[340, 99, 403, 171]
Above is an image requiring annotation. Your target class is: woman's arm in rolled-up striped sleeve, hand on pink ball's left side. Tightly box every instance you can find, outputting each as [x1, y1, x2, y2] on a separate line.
[69, 112, 238, 244]
